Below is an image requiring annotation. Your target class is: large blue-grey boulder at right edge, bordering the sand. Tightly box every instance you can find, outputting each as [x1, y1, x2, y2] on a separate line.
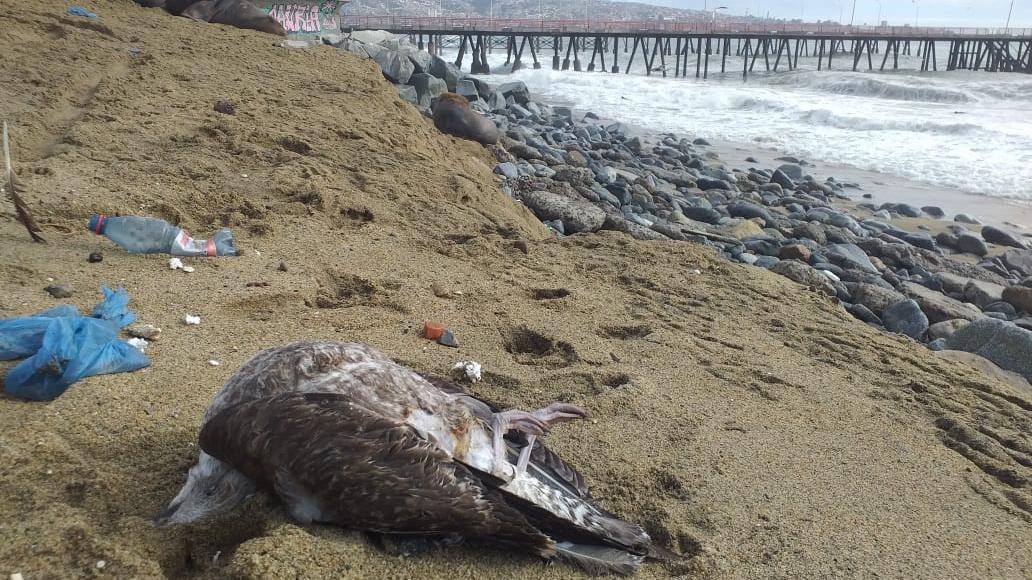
[946, 317, 1032, 380]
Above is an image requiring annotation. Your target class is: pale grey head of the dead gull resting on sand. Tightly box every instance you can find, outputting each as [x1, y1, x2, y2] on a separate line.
[154, 451, 256, 525]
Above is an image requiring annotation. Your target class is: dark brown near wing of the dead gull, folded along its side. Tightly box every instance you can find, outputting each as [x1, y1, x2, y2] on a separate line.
[200, 392, 555, 557]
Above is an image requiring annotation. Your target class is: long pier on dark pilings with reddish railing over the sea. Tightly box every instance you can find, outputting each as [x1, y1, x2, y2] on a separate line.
[342, 17, 1032, 78]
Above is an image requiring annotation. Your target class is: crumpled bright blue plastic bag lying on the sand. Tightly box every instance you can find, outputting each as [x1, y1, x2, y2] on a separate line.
[0, 288, 151, 400]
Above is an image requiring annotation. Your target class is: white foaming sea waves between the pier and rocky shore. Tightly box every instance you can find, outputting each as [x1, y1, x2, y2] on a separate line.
[464, 46, 1032, 202]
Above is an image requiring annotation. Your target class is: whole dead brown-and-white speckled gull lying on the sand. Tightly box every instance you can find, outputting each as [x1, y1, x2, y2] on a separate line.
[159, 342, 652, 574]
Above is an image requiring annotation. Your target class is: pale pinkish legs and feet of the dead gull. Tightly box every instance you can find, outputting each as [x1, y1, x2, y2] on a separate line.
[492, 402, 587, 480]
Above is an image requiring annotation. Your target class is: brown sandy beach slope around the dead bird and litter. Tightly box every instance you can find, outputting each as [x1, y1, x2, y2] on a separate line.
[0, 0, 1032, 579]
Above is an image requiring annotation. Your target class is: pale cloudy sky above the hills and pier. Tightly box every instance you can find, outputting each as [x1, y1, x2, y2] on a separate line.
[644, 0, 1032, 28]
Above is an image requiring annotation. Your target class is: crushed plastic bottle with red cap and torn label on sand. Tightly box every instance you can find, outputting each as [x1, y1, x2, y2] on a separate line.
[89, 214, 236, 256]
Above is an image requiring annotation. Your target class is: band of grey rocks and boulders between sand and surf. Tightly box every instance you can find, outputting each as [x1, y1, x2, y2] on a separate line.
[340, 33, 1032, 387]
